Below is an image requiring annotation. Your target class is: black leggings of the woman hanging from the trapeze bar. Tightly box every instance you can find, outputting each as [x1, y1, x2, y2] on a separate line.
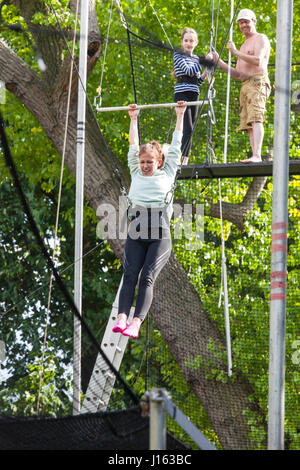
[118, 230, 172, 321]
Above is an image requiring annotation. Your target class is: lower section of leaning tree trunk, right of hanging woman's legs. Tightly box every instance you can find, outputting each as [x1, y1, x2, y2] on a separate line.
[151, 257, 260, 450]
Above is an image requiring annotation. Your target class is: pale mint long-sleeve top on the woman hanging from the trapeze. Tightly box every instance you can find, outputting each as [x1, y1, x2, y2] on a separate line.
[128, 131, 182, 221]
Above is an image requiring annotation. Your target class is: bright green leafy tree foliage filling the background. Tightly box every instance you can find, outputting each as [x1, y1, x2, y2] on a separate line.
[0, 0, 300, 449]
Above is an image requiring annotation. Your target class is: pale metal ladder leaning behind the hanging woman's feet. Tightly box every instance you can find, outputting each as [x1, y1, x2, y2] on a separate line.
[80, 278, 134, 413]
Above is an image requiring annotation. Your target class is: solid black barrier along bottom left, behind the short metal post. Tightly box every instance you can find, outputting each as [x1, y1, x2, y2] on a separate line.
[0, 408, 188, 451]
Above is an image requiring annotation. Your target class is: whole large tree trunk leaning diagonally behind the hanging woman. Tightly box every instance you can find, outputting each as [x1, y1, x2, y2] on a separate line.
[0, 0, 268, 449]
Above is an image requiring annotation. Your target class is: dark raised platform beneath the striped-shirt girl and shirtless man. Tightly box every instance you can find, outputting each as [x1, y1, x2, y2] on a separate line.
[177, 159, 300, 180]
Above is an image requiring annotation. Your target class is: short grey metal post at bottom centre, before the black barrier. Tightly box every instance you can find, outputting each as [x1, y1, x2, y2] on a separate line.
[149, 388, 167, 450]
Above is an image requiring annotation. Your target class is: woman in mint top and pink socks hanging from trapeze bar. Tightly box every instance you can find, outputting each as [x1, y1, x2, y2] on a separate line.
[113, 105, 186, 338]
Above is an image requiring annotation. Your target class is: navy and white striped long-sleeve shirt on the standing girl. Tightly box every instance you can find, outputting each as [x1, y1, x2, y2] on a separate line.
[173, 52, 204, 93]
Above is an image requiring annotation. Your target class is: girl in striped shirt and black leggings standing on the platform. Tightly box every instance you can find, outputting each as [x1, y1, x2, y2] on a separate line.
[173, 28, 206, 165]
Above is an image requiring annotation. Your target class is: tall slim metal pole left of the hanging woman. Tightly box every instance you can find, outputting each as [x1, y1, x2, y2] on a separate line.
[73, 0, 89, 414]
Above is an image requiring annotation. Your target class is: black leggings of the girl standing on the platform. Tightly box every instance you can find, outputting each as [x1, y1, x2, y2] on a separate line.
[174, 91, 199, 157]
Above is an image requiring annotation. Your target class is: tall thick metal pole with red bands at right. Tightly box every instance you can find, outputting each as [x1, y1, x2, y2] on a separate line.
[268, 0, 293, 450]
